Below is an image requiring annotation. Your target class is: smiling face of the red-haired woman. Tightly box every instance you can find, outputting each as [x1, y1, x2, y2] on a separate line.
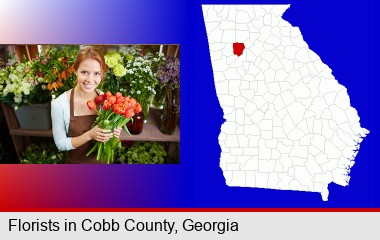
[76, 58, 102, 93]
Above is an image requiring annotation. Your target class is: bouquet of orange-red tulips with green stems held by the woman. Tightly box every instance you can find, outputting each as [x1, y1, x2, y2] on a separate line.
[86, 91, 142, 164]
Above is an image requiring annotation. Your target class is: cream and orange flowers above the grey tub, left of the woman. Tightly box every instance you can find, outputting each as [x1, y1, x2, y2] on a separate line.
[0, 47, 77, 109]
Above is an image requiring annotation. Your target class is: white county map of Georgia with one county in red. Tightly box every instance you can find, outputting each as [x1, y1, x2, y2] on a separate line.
[202, 5, 369, 201]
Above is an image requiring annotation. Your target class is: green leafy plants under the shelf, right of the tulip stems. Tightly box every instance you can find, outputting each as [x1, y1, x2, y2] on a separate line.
[116, 142, 167, 164]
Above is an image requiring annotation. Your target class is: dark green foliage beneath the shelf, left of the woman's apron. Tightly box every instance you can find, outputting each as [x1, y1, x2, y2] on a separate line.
[20, 141, 66, 164]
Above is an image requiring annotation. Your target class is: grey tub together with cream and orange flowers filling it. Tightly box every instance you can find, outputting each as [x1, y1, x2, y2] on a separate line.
[0, 47, 77, 130]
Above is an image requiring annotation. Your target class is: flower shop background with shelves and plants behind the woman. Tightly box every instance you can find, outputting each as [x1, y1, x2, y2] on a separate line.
[0, 45, 180, 164]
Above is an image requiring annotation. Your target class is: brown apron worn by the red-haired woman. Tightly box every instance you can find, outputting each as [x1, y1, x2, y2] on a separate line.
[66, 89, 102, 163]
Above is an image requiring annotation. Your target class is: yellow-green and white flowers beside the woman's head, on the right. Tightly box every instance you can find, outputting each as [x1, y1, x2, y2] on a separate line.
[102, 47, 165, 117]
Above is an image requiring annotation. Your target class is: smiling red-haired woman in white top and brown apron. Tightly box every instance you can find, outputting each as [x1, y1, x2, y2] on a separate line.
[51, 46, 121, 163]
